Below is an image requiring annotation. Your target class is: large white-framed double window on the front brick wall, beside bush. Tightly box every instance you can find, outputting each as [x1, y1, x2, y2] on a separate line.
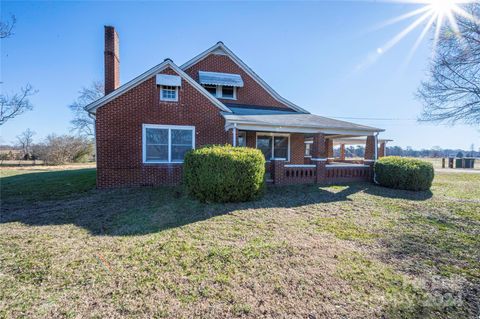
[142, 124, 195, 163]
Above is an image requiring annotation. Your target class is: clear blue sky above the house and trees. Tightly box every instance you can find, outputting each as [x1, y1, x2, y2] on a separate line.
[0, 1, 480, 149]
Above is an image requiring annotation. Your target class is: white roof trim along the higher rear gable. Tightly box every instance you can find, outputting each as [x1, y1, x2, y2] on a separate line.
[180, 42, 310, 113]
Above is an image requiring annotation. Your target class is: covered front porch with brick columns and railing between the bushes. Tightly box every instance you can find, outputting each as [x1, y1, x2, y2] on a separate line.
[226, 114, 387, 185]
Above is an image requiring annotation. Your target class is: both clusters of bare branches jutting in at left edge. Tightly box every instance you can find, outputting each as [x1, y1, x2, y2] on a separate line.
[0, 15, 36, 125]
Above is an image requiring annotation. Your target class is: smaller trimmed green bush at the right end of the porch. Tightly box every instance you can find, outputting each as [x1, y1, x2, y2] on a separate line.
[375, 156, 434, 191]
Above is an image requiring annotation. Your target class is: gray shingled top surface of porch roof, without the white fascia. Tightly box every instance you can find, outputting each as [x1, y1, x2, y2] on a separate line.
[223, 113, 384, 132]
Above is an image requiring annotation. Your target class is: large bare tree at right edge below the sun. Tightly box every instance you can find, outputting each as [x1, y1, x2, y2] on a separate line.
[417, 3, 480, 125]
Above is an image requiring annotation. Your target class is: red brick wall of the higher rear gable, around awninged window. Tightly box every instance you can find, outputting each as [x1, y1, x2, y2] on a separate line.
[185, 54, 289, 108]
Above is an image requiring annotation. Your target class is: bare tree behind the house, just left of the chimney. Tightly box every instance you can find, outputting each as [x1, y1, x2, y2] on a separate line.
[68, 81, 104, 137]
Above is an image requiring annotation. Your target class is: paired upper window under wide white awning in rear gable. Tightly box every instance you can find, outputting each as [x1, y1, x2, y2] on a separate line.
[198, 71, 243, 100]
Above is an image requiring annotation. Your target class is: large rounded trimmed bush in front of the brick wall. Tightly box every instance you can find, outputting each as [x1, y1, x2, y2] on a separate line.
[183, 145, 265, 202]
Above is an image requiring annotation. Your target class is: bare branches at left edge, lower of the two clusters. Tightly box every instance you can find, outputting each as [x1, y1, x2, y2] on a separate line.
[0, 84, 36, 125]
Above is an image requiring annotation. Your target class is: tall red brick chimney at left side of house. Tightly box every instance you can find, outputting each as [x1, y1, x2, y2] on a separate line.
[105, 25, 120, 95]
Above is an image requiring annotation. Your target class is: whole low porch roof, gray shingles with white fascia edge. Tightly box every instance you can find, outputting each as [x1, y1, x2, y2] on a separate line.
[222, 112, 384, 136]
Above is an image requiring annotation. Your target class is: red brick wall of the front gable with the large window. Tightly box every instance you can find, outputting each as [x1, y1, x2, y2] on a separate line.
[96, 69, 231, 188]
